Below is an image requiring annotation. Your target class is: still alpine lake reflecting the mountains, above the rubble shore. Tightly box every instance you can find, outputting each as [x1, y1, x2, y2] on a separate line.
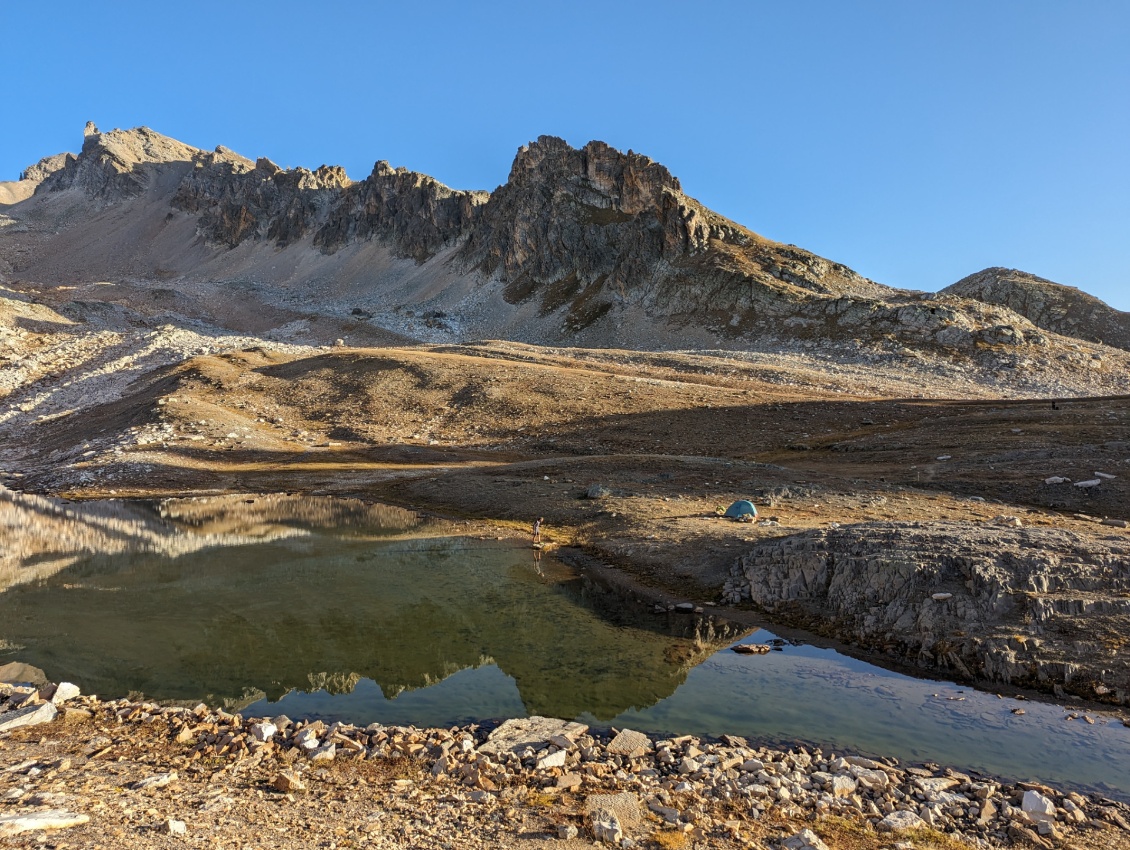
[0, 497, 1130, 799]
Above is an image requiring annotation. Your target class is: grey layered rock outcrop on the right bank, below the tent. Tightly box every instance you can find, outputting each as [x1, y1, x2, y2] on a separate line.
[727, 522, 1130, 704]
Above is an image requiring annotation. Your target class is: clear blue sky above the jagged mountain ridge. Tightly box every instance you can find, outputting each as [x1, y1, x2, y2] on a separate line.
[0, 0, 1130, 310]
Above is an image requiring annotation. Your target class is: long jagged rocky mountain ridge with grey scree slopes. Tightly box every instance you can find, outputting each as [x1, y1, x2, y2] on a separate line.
[0, 124, 1130, 361]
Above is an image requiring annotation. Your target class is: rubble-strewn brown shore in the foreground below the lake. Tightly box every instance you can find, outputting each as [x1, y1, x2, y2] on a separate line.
[0, 683, 1130, 850]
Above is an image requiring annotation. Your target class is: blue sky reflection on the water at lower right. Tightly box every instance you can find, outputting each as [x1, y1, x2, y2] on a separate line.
[612, 632, 1130, 798]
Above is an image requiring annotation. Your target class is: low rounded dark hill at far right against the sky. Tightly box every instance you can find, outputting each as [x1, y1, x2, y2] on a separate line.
[942, 267, 1130, 350]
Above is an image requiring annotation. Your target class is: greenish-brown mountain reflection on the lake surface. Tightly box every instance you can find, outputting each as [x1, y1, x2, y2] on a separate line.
[0, 483, 740, 719]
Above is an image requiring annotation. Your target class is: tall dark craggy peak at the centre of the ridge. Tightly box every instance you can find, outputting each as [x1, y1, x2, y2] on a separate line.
[462, 136, 890, 336]
